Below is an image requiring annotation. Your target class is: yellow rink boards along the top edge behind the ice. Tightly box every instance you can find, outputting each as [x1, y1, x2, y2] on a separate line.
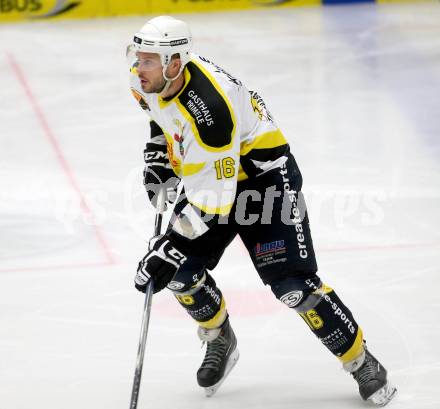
[0, 0, 434, 21]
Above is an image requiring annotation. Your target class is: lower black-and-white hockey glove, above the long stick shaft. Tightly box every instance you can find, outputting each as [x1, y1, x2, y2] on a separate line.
[134, 235, 186, 293]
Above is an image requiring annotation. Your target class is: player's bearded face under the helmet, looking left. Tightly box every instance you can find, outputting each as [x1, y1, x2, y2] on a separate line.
[136, 52, 166, 94]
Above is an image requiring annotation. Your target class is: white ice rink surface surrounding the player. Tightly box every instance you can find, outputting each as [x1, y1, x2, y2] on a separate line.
[0, 3, 440, 409]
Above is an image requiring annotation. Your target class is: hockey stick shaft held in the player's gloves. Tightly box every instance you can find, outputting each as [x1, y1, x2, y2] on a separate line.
[130, 189, 165, 409]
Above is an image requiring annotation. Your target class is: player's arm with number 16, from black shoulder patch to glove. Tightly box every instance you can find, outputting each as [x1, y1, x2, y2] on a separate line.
[136, 57, 240, 291]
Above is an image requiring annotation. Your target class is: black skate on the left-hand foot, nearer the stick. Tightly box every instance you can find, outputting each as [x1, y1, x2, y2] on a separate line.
[197, 318, 240, 397]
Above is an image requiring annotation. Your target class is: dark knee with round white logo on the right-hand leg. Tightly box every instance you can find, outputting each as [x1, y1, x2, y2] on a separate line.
[270, 274, 322, 313]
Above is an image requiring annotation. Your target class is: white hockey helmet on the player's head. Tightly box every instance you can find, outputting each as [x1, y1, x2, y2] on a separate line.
[129, 16, 192, 79]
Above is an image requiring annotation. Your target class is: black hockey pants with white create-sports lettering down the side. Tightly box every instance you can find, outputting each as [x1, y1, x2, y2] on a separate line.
[168, 154, 317, 284]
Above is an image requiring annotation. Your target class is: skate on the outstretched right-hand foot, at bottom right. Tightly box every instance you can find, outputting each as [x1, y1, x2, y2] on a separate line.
[344, 344, 397, 406]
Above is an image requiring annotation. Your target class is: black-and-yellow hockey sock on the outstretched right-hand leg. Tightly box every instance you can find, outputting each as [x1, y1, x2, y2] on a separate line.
[296, 280, 364, 363]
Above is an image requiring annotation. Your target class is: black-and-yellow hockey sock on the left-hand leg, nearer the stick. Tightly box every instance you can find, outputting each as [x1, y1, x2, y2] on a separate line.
[173, 271, 227, 329]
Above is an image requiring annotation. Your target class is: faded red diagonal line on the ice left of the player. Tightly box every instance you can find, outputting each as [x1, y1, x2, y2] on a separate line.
[7, 53, 115, 264]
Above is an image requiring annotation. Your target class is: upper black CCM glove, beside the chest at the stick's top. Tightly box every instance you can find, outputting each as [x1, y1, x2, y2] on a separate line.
[144, 143, 180, 207]
